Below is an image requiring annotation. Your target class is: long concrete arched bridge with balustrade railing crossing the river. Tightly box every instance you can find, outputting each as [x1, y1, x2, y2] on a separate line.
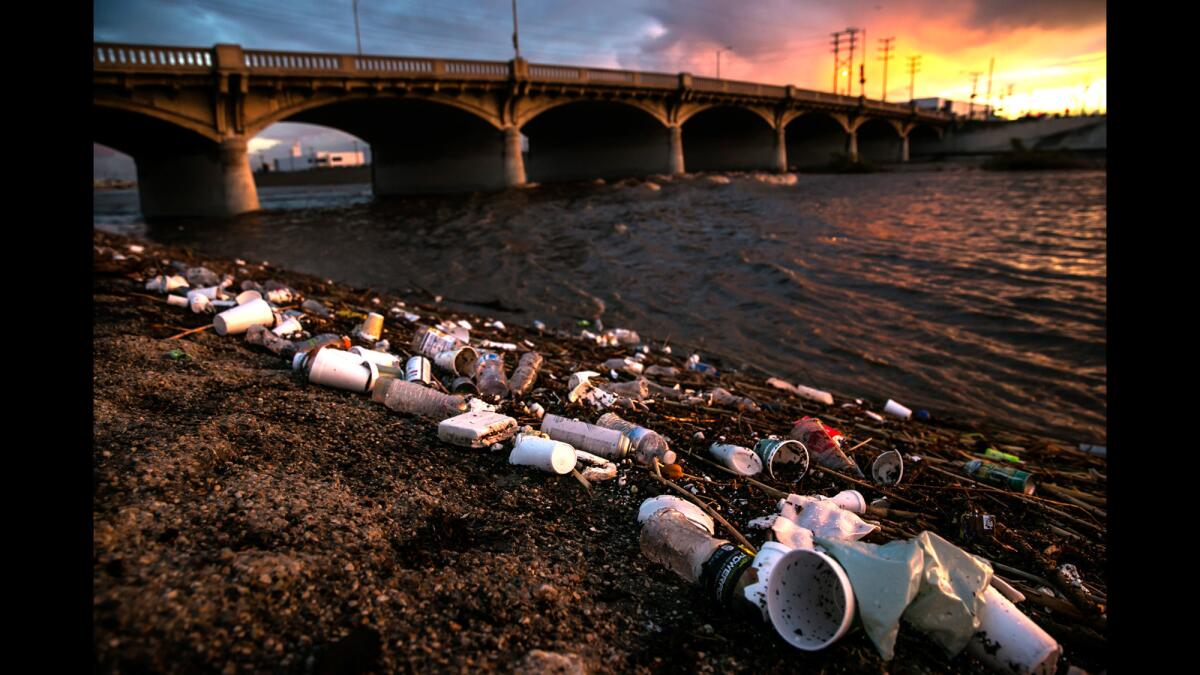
[92, 43, 953, 217]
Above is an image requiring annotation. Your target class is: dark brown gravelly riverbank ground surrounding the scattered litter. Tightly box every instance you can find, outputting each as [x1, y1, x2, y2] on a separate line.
[92, 232, 1108, 673]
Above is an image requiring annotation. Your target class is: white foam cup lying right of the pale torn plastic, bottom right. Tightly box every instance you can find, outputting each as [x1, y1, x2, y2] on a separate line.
[967, 586, 1062, 675]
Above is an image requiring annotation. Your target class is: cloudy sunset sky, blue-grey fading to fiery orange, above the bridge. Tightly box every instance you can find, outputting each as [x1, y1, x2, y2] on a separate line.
[92, 0, 1108, 170]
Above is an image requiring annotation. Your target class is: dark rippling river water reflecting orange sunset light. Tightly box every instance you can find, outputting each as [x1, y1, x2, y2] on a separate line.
[94, 166, 1108, 443]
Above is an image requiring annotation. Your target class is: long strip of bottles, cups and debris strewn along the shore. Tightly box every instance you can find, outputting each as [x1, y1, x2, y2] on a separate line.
[108, 234, 1106, 673]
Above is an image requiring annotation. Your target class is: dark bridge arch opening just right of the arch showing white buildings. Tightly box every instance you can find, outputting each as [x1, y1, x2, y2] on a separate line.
[521, 98, 671, 181]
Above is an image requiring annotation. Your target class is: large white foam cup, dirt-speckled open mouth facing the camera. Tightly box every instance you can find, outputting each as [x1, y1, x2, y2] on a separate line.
[767, 549, 854, 651]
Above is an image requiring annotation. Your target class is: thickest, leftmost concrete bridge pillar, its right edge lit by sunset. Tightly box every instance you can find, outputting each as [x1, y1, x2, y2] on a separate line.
[134, 132, 259, 217]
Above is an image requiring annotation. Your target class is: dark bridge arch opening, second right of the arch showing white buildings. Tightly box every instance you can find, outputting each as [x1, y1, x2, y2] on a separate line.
[682, 106, 782, 172]
